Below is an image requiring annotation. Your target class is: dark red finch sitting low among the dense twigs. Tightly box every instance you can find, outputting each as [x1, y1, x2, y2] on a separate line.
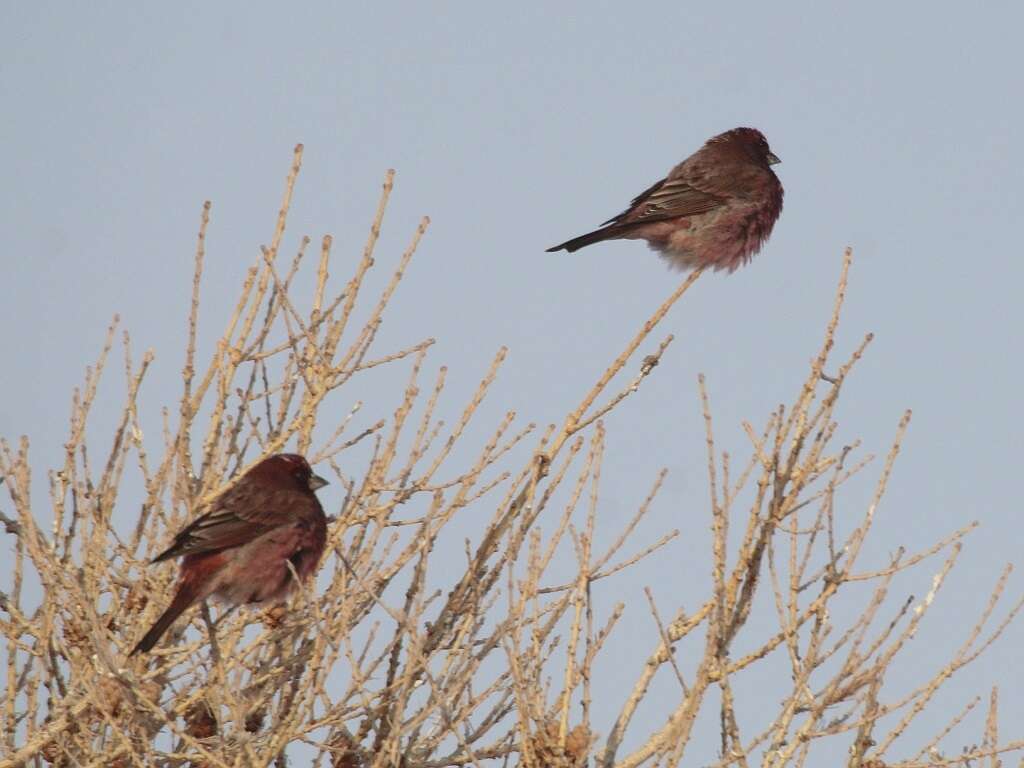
[131, 454, 327, 655]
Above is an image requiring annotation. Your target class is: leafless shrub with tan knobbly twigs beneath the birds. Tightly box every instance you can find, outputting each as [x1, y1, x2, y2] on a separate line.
[0, 146, 1024, 768]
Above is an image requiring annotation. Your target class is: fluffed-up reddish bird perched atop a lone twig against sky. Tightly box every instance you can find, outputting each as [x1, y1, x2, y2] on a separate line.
[548, 128, 782, 272]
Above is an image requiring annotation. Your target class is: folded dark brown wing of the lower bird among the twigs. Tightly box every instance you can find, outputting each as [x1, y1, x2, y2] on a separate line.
[153, 481, 305, 562]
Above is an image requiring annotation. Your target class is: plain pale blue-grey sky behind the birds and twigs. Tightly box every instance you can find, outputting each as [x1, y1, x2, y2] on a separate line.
[0, 2, 1024, 758]
